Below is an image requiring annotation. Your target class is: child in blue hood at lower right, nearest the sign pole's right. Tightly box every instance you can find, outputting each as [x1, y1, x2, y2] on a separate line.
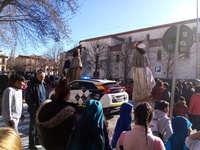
[165, 116, 192, 150]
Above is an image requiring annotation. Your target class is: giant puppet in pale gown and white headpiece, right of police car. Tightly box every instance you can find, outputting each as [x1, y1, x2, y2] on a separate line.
[132, 42, 155, 102]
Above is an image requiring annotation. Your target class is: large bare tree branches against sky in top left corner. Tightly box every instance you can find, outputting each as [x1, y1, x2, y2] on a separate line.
[0, 0, 79, 50]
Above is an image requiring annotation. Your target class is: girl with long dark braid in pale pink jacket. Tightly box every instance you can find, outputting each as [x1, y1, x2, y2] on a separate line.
[116, 102, 165, 150]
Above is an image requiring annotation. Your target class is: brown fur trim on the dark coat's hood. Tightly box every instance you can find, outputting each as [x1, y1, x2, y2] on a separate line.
[36, 100, 76, 128]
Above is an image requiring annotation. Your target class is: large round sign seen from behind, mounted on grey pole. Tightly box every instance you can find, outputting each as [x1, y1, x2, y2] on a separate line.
[162, 25, 194, 53]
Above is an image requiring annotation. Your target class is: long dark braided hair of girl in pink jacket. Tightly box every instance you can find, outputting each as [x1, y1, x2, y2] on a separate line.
[134, 102, 153, 145]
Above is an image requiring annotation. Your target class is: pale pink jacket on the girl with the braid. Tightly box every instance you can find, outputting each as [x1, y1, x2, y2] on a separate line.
[116, 125, 165, 150]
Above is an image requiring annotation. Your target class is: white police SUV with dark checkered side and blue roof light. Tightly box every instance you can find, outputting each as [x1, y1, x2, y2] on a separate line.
[49, 78, 129, 114]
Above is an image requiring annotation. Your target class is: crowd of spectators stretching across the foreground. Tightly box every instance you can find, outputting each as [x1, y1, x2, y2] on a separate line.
[0, 51, 200, 150]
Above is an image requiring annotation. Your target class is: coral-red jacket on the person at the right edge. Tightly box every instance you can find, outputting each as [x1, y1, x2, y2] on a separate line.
[188, 93, 200, 115]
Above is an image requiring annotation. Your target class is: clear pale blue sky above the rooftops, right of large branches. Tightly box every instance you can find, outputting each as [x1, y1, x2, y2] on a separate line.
[2, 0, 200, 55]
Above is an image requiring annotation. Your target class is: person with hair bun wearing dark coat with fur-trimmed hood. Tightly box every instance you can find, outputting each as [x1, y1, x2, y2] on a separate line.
[36, 79, 77, 150]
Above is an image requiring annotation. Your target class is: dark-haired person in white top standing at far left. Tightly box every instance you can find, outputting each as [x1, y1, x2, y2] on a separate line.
[1, 75, 25, 132]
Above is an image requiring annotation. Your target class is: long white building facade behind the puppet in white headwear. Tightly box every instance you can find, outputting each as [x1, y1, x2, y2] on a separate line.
[80, 19, 200, 79]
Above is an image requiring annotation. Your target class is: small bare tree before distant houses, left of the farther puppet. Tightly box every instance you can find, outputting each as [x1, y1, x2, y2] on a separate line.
[43, 43, 63, 75]
